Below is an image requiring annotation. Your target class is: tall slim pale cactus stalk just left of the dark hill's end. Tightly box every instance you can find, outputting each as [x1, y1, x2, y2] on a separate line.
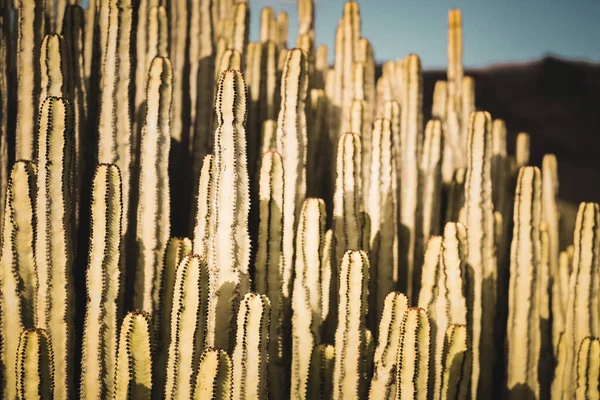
[399, 54, 423, 298]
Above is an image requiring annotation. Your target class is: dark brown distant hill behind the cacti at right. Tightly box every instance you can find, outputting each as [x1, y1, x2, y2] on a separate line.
[380, 56, 600, 204]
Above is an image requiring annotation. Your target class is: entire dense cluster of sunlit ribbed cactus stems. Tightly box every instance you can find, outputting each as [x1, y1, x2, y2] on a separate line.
[0, 0, 600, 400]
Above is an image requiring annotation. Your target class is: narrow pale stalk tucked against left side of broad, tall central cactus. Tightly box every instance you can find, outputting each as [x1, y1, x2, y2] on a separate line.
[193, 154, 216, 258]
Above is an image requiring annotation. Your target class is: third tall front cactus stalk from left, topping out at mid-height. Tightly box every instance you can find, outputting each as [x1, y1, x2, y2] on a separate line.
[80, 164, 123, 399]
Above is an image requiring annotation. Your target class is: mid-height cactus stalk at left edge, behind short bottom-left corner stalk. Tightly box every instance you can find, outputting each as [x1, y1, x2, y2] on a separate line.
[0, 161, 37, 398]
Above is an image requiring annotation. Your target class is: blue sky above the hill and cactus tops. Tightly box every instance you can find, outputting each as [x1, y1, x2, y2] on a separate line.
[249, 0, 600, 68]
